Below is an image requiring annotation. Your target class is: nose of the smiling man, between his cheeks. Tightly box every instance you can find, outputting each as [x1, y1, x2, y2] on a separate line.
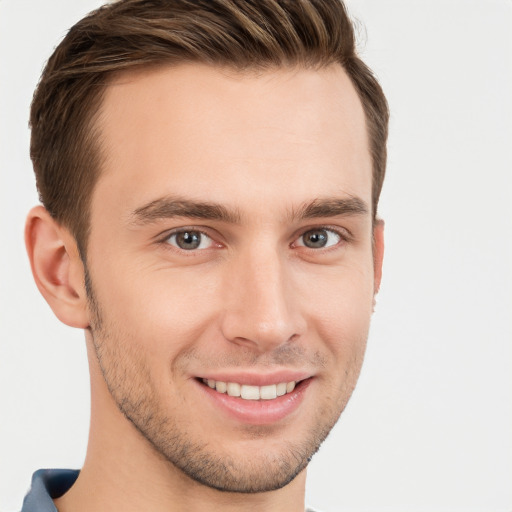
[222, 244, 306, 353]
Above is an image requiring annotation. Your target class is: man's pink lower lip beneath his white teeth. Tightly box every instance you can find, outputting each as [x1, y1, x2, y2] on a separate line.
[196, 378, 312, 425]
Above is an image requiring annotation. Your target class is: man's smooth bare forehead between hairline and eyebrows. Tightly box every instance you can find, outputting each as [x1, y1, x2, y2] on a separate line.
[92, 60, 371, 220]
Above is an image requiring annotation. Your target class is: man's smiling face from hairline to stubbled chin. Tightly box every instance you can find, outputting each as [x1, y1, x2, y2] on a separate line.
[87, 64, 381, 492]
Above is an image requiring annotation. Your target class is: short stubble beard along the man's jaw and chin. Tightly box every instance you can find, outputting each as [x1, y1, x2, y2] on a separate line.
[85, 270, 364, 493]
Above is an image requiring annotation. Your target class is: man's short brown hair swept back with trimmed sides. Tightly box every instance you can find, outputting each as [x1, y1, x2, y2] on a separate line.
[30, 0, 389, 258]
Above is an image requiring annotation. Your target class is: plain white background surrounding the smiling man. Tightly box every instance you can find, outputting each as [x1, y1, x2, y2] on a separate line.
[0, 0, 512, 512]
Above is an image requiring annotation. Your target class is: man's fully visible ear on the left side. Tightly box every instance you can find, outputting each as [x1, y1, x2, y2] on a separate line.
[25, 206, 89, 329]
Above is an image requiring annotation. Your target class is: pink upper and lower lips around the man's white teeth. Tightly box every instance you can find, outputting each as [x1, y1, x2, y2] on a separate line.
[195, 374, 313, 425]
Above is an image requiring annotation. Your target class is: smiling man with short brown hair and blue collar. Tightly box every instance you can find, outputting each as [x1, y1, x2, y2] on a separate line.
[23, 0, 388, 512]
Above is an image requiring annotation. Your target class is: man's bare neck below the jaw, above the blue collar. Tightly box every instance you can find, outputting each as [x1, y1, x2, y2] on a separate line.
[55, 338, 306, 512]
